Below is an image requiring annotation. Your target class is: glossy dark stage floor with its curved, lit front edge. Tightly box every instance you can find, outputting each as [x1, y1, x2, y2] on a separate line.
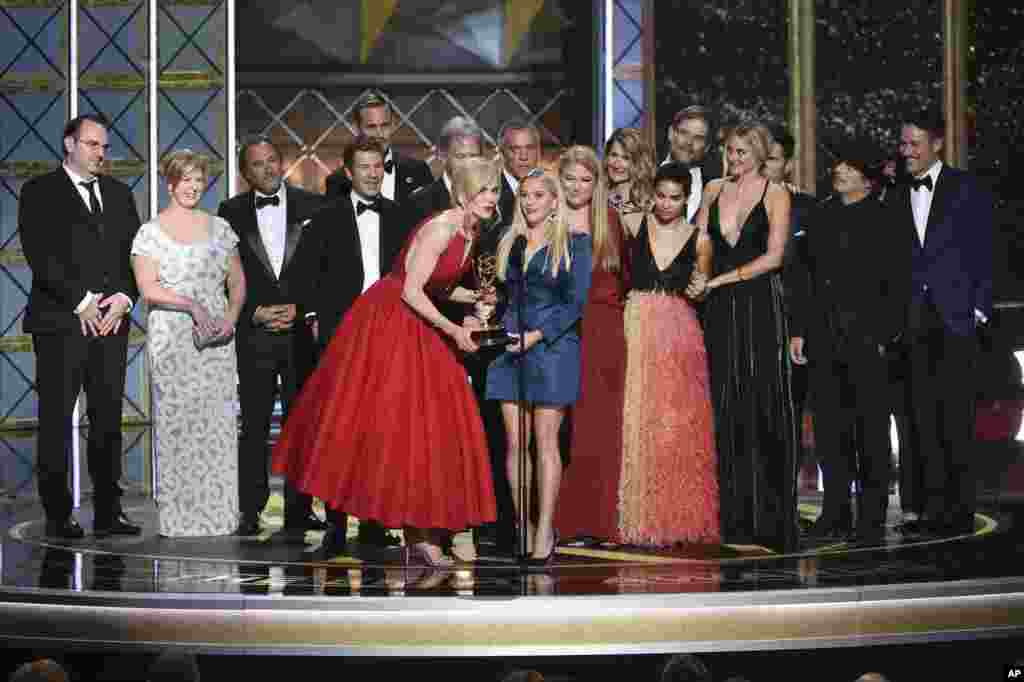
[0, 477, 1024, 656]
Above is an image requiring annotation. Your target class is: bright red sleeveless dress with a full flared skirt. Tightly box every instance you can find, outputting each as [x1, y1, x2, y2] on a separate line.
[273, 228, 496, 530]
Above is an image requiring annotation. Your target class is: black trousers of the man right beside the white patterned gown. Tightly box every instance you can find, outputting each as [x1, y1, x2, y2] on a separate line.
[236, 322, 313, 526]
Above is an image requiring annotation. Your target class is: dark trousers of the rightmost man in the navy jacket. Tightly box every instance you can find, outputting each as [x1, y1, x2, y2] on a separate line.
[907, 299, 978, 529]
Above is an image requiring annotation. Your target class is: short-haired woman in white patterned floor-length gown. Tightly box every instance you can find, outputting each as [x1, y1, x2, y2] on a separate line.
[132, 150, 246, 537]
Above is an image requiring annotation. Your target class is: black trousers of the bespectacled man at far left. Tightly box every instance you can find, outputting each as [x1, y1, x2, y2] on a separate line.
[33, 334, 128, 523]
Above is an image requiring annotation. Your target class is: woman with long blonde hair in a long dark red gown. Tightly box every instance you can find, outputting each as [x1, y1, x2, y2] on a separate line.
[555, 145, 627, 540]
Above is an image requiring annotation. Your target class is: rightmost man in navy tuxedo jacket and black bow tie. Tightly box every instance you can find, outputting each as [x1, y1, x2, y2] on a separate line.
[887, 112, 994, 535]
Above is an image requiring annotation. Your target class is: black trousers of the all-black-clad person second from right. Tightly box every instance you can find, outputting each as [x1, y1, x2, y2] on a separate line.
[810, 342, 890, 534]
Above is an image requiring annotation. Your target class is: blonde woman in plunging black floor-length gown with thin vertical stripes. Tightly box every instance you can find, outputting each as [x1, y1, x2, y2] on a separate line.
[697, 125, 798, 551]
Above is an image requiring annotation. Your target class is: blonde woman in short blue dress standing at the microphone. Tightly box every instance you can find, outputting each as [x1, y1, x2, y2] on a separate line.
[486, 169, 591, 564]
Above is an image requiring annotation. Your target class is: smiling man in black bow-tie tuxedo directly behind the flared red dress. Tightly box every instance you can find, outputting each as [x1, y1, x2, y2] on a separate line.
[310, 136, 412, 555]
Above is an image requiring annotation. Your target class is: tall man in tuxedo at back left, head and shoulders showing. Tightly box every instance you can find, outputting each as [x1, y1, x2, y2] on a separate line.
[327, 92, 434, 206]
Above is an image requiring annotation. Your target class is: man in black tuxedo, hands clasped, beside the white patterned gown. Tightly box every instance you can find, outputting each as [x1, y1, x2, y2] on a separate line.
[217, 137, 327, 537]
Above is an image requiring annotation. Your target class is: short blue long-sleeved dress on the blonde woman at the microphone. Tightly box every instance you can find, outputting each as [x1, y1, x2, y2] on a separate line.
[486, 235, 591, 406]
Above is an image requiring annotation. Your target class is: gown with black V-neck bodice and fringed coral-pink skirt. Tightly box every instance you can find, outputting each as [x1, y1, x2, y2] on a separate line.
[618, 219, 719, 546]
